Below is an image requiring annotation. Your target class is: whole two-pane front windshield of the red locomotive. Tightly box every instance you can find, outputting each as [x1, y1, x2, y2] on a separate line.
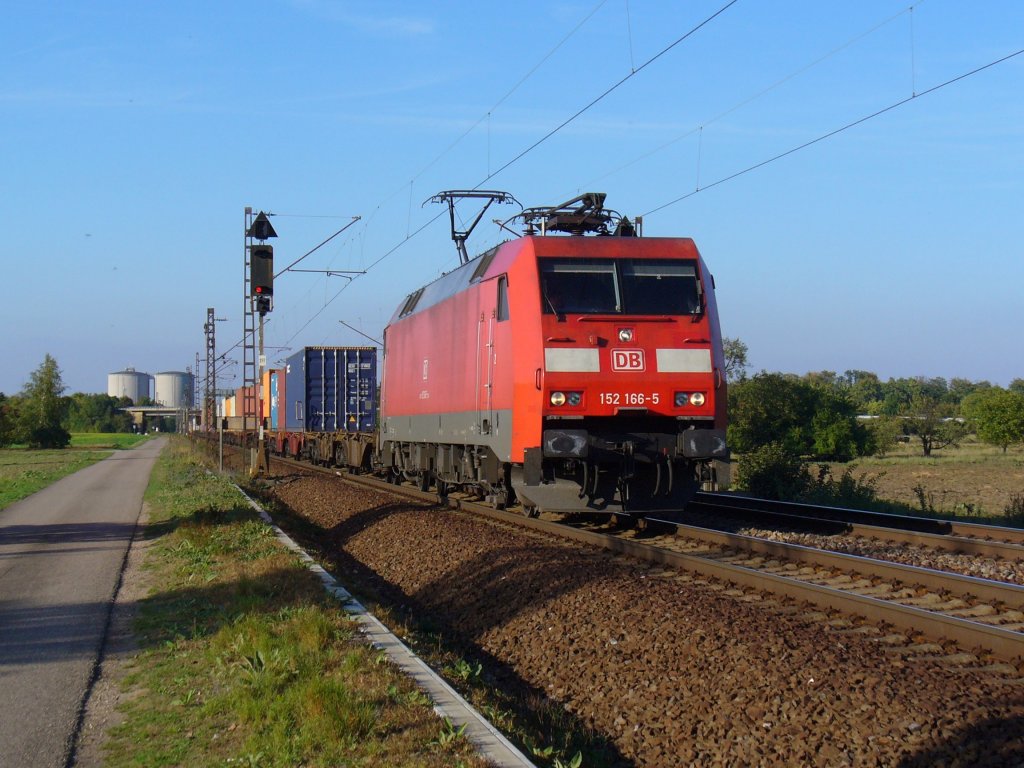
[540, 259, 701, 315]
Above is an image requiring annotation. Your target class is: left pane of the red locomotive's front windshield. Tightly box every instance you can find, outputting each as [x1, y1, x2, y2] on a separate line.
[541, 259, 622, 314]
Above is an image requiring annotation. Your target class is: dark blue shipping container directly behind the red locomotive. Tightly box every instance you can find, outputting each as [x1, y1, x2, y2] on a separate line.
[285, 347, 377, 432]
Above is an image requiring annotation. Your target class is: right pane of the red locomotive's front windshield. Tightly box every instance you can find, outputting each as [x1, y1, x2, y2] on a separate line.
[620, 259, 700, 314]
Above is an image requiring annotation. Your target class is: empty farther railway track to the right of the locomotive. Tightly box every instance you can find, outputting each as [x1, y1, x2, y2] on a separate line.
[684, 499, 1024, 560]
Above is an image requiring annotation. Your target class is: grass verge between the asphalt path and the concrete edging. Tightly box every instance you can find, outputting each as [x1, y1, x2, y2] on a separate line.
[104, 440, 483, 768]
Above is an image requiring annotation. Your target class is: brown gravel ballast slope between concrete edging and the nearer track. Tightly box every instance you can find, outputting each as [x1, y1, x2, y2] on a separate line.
[264, 475, 1024, 766]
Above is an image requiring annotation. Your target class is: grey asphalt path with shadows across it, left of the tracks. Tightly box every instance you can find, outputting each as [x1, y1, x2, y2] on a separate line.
[0, 438, 167, 768]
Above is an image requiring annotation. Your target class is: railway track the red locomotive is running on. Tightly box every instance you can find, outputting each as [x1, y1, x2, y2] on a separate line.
[256, 458, 1024, 672]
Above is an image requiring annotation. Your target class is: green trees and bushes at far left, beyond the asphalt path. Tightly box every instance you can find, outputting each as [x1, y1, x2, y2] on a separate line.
[0, 354, 142, 449]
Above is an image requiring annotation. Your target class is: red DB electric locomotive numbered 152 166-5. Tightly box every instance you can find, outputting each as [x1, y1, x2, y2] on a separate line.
[379, 194, 728, 514]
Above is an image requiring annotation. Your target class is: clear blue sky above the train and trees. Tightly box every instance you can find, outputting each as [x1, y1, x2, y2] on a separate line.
[0, 0, 1024, 393]
